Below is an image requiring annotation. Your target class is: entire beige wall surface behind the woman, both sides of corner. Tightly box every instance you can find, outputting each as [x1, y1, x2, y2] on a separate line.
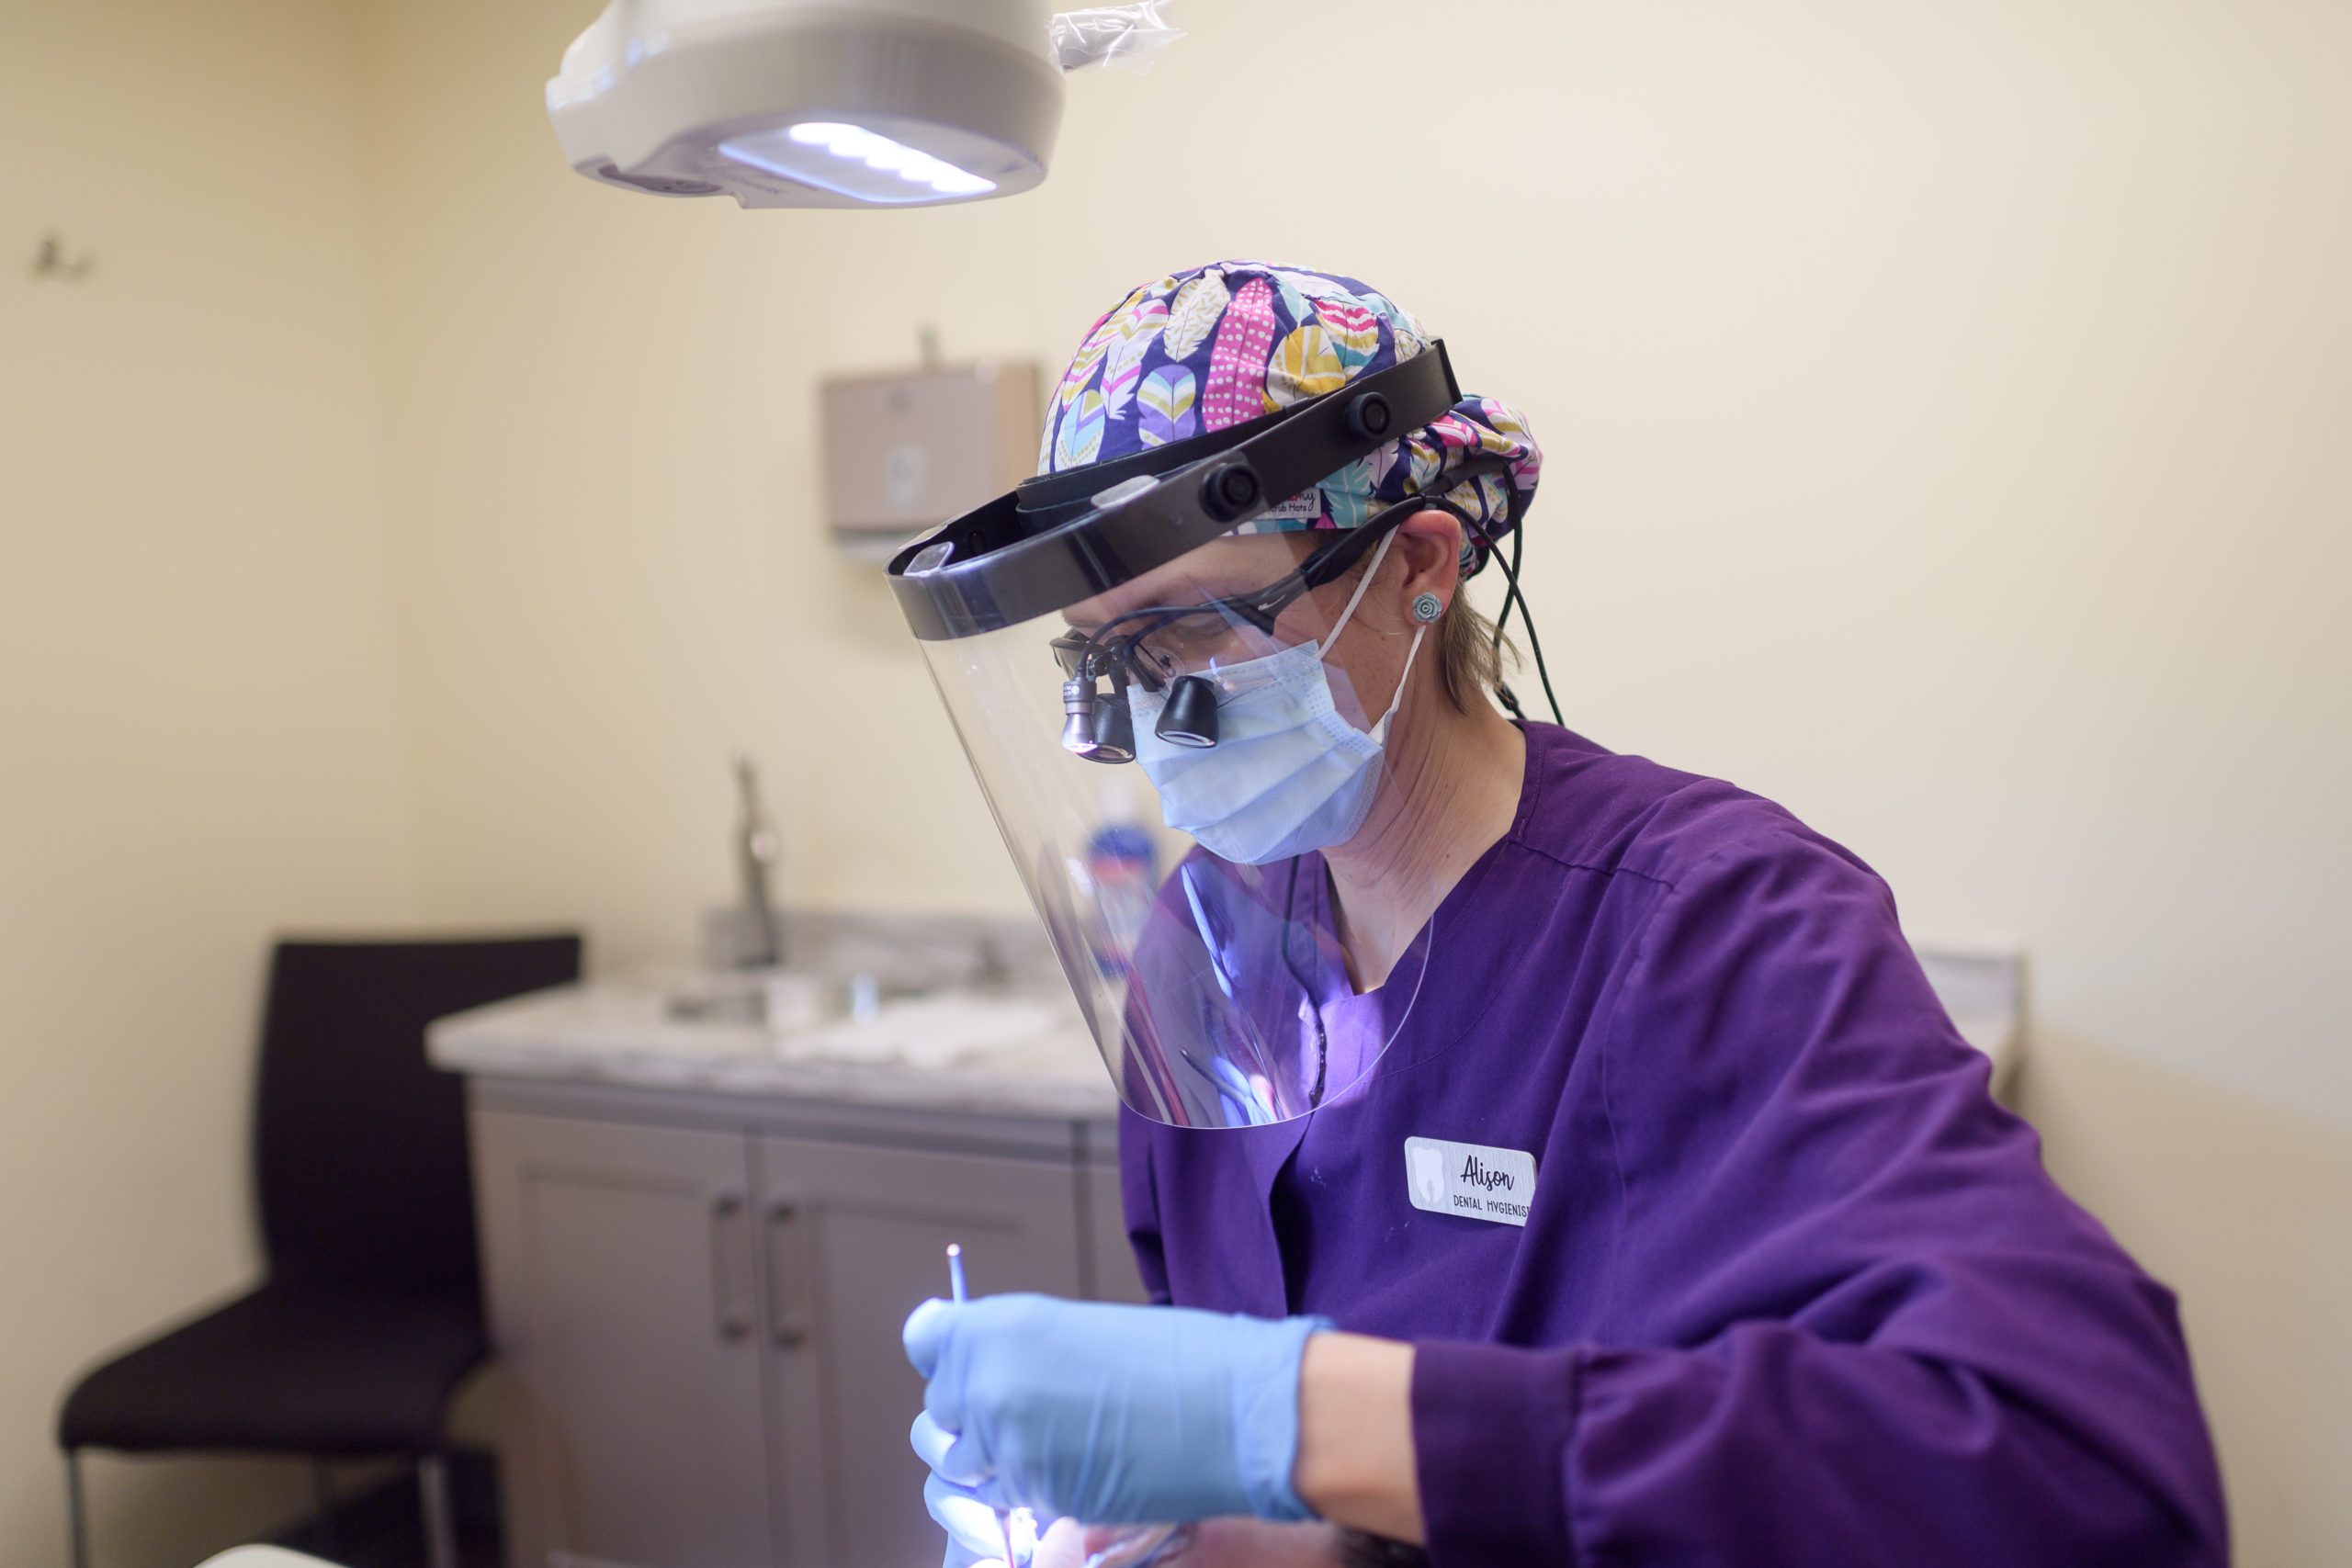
[0, 0, 2352, 1568]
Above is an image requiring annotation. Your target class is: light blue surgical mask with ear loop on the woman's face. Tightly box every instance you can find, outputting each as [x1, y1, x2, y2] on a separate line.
[1126, 538, 1428, 865]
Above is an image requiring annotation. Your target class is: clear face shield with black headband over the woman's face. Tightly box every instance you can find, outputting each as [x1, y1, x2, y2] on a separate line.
[891, 348, 1456, 1126]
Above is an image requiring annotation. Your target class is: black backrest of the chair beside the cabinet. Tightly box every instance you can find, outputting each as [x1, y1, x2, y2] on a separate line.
[254, 936, 581, 1295]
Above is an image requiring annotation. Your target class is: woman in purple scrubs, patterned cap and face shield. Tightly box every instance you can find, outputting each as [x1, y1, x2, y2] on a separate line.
[891, 261, 2227, 1568]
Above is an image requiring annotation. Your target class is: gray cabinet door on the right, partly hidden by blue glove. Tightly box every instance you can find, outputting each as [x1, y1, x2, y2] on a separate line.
[757, 1138, 1080, 1568]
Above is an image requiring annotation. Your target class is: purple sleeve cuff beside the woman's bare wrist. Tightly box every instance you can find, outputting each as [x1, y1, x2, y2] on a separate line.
[1414, 1340, 1583, 1568]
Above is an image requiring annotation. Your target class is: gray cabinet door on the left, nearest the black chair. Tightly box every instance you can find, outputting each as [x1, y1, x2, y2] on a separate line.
[475, 1112, 774, 1568]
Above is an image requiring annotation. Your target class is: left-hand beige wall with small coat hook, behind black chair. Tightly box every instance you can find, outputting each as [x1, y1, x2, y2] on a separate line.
[0, 0, 416, 1568]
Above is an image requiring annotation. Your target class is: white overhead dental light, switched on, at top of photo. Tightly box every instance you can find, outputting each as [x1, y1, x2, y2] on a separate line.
[548, 0, 1181, 207]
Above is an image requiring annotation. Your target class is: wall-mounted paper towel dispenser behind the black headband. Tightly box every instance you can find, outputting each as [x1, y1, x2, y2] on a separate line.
[819, 360, 1042, 562]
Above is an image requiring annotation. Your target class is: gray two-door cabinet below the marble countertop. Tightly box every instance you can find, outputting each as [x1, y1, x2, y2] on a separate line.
[473, 1079, 1141, 1568]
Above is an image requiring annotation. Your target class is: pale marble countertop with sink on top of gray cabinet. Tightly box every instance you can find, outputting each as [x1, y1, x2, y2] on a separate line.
[425, 966, 1120, 1119]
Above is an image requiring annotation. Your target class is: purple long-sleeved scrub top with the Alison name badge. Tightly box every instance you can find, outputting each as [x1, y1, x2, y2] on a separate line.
[1120, 724, 2227, 1568]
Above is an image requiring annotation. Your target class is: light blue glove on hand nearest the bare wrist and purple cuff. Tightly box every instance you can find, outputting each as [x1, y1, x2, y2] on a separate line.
[906, 1295, 1331, 1540]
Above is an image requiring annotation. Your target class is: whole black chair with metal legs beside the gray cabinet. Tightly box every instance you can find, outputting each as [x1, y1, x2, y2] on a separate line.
[56, 936, 581, 1568]
